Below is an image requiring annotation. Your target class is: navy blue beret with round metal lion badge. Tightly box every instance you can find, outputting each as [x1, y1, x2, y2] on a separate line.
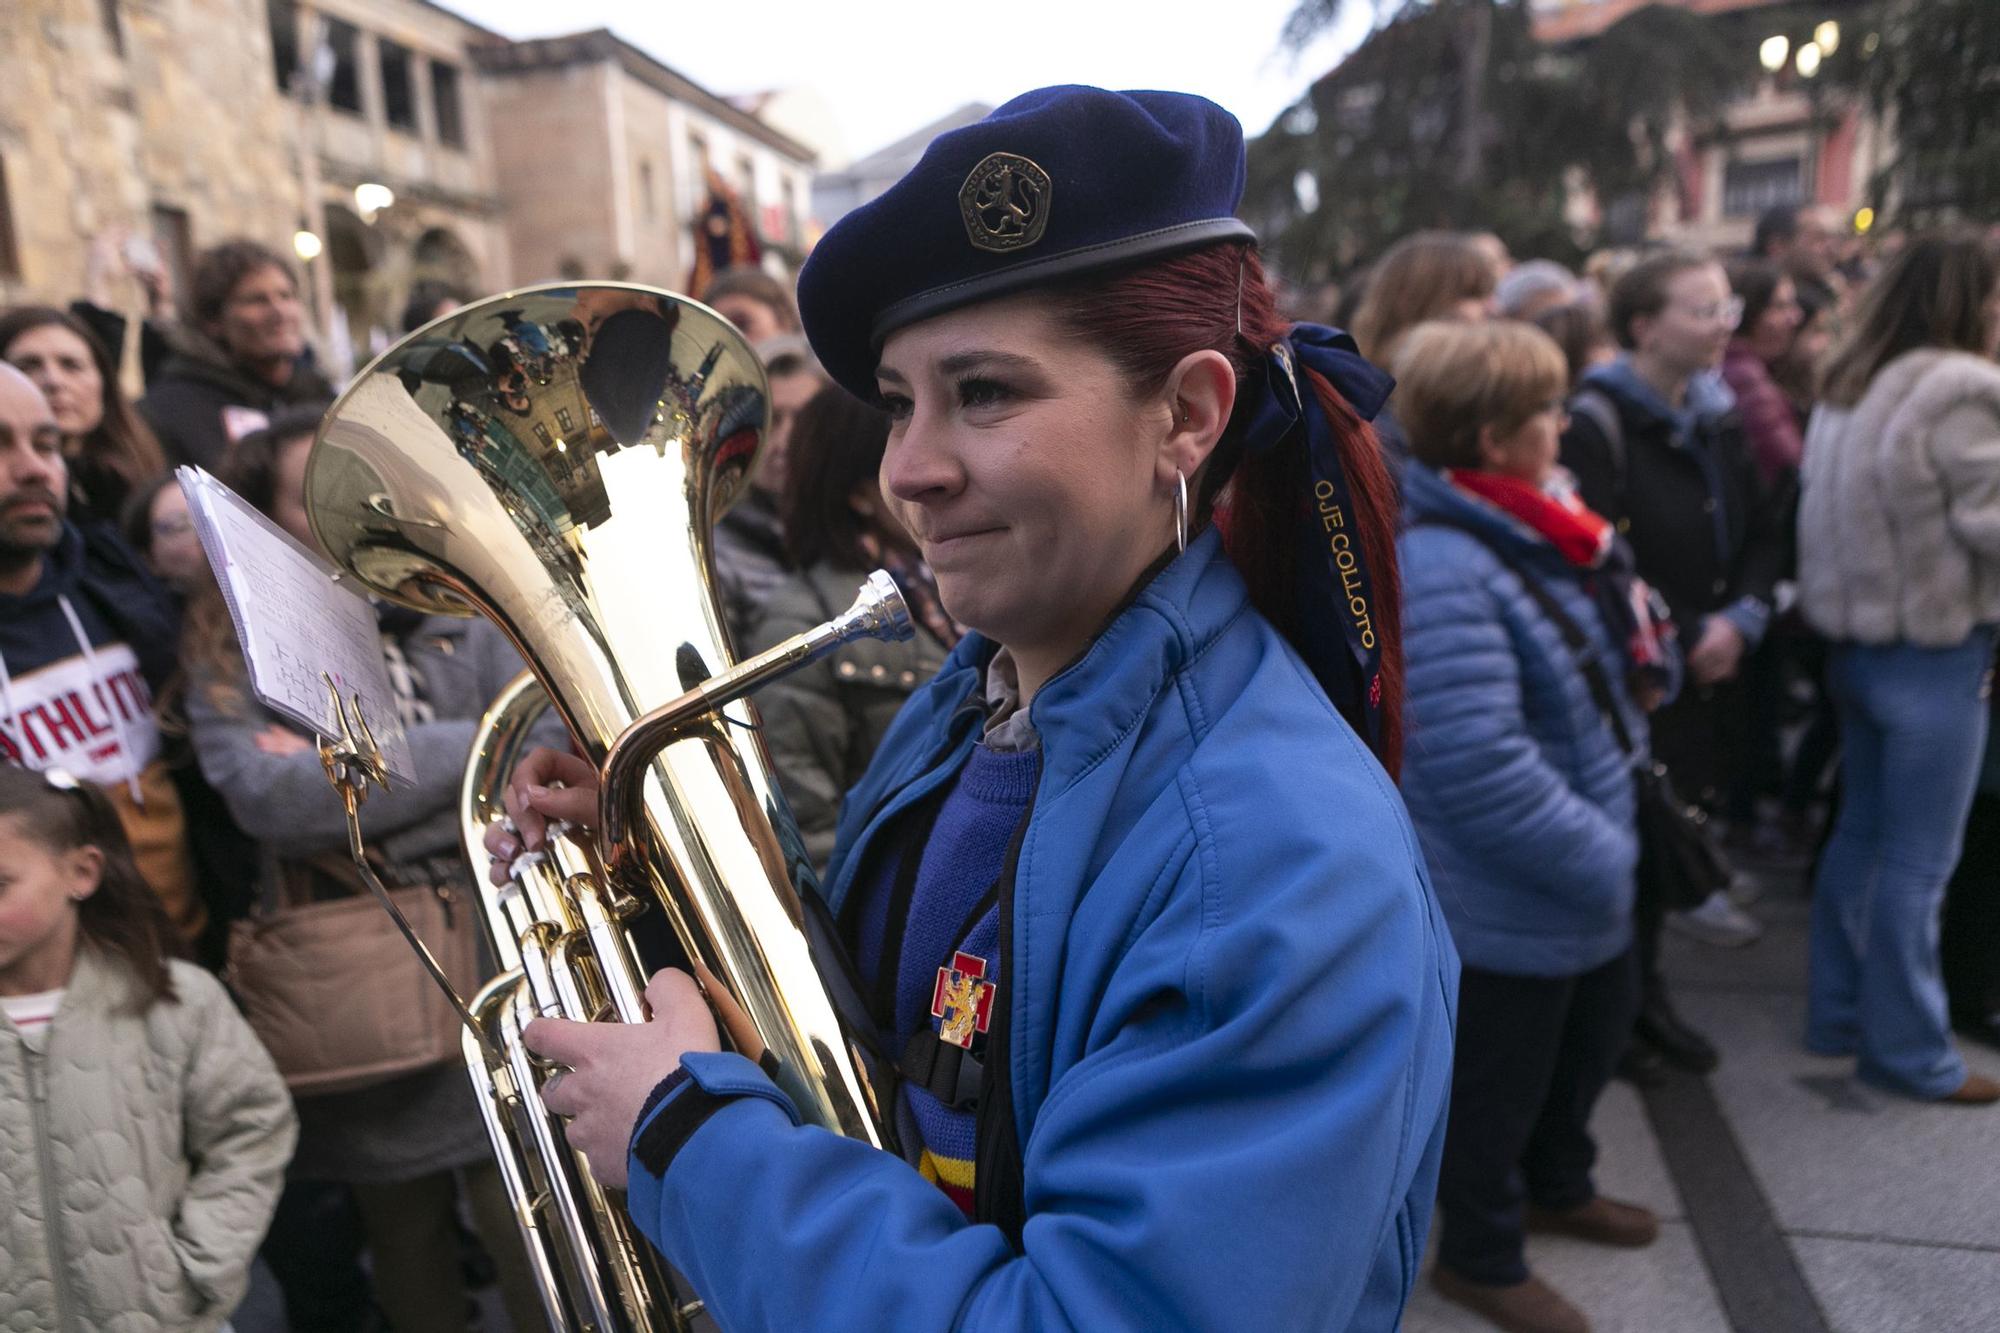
[798, 86, 1256, 398]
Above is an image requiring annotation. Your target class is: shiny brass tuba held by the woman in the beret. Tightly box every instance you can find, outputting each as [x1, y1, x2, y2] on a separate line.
[306, 282, 910, 1333]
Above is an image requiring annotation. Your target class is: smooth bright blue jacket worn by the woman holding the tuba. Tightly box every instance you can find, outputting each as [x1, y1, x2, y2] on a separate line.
[628, 530, 1458, 1333]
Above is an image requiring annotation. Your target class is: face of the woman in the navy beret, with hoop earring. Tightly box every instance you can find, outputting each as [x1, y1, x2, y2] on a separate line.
[876, 294, 1234, 679]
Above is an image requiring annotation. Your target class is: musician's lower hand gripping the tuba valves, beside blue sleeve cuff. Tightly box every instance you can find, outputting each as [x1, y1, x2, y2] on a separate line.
[520, 967, 722, 1189]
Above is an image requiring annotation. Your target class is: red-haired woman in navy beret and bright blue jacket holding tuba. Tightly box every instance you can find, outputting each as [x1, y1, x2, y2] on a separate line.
[488, 88, 1458, 1329]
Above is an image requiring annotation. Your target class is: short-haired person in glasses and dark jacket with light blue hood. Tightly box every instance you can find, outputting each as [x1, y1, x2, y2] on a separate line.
[1562, 250, 1786, 1077]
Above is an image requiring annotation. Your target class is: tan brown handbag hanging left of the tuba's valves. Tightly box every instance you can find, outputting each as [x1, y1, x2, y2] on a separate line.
[224, 853, 480, 1097]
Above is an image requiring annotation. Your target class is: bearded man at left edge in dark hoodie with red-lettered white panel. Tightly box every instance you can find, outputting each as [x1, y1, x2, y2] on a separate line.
[0, 362, 206, 943]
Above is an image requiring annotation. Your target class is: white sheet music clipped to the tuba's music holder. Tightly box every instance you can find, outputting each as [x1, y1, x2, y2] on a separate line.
[174, 466, 416, 783]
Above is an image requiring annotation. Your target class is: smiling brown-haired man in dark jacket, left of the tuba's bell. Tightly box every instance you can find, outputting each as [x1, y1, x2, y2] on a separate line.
[138, 240, 334, 470]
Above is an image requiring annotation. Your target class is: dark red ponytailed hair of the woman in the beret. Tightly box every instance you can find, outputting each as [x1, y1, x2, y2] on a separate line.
[1048, 244, 1402, 777]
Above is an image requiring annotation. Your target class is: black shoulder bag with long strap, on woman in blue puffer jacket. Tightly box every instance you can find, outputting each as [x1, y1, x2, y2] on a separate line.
[1420, 518, 1734, 911]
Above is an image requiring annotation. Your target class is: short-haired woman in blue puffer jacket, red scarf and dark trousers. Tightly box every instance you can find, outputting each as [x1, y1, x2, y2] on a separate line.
[1396, 324, 1670, 1331]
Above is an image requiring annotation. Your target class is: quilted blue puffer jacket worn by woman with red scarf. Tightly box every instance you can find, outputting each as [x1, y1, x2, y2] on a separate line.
[1396, 462, 1646, 977]
